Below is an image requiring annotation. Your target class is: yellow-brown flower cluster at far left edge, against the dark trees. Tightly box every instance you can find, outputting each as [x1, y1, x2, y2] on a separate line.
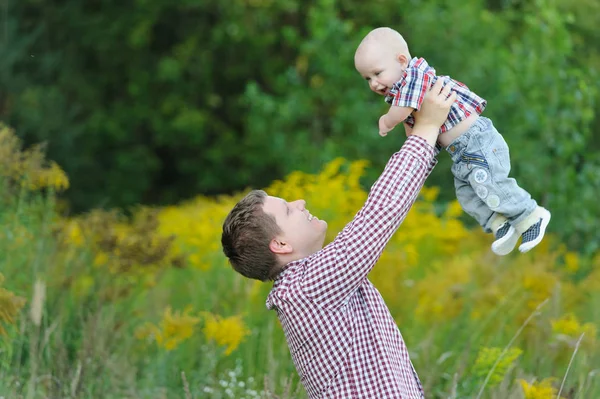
[0, 123, 69, 195]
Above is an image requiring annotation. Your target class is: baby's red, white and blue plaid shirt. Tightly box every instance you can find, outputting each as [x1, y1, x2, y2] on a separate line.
[385, 58, 487, 133]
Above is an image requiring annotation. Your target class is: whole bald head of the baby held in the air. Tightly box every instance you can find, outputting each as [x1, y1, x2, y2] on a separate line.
[354, 28, 411, 96]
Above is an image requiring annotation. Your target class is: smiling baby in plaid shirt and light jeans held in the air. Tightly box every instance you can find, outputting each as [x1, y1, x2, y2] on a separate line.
[354, 28, 550, 255]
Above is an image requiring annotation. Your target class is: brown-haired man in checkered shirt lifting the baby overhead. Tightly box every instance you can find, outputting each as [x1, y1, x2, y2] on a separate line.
[221, 79, 456, 399]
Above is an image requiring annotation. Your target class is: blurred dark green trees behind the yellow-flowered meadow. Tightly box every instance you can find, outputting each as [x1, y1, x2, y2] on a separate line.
[0, 0, 600, 252]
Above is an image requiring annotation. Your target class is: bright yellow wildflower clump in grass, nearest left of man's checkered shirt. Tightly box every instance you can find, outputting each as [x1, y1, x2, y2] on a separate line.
[204, 312, 250, 356]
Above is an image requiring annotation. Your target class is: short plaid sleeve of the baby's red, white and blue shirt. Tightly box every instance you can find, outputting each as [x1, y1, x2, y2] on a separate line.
[387, 68, 432, 110]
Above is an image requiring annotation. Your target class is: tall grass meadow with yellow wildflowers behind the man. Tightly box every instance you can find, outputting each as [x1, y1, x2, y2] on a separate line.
[0, 124, 600, 399]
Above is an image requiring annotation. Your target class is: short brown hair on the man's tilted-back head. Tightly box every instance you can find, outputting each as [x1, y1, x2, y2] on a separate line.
[221, 190, 281, 281]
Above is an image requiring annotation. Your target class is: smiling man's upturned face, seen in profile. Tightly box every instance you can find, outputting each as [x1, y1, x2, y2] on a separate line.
[263, 196, 327, 258]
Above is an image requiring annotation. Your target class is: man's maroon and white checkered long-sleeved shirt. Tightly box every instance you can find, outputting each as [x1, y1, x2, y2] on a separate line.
[266, 136, 439, 399]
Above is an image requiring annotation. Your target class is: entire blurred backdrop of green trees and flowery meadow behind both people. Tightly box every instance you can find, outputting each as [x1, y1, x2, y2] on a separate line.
[0, 0, 600, 399]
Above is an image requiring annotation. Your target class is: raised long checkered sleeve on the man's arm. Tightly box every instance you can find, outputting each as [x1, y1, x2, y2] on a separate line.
[302, 136, 437, 307]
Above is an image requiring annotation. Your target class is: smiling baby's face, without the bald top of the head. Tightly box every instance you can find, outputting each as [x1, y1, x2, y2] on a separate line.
[354, 45, 407, 96]
